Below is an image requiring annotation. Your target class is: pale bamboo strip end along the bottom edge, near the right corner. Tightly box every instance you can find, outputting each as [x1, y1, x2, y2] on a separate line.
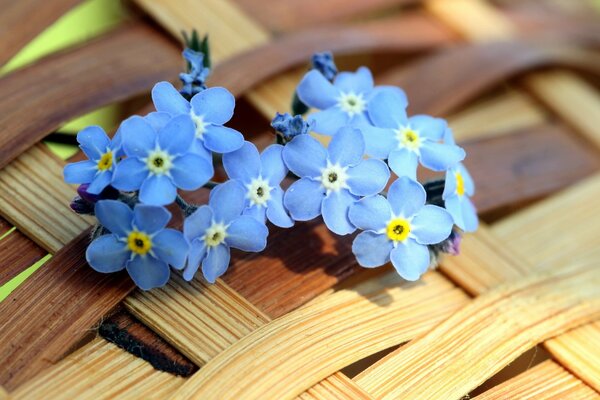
[474, 360, 600, 400]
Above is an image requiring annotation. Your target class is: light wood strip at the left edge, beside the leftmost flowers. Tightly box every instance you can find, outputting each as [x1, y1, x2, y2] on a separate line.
[0, 143, 92, 253]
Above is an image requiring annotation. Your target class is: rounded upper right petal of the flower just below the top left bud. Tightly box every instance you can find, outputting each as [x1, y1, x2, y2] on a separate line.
[190, 87, 235, 125]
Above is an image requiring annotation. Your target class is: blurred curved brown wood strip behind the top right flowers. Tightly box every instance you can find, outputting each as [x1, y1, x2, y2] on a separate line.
[378, 41, 600, 115]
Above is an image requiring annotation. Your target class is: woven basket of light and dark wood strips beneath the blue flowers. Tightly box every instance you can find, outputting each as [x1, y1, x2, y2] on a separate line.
[0, 0, 600, 400]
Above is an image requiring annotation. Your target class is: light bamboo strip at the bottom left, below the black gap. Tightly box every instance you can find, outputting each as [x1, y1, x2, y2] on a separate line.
[11, 338, 185, 400]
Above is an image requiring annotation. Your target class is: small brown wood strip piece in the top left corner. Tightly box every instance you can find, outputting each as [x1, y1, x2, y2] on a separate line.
[0, 0, 80, 65]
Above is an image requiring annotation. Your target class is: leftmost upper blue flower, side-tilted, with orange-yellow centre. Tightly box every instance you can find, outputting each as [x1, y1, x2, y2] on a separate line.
[64, 126, 120, 194]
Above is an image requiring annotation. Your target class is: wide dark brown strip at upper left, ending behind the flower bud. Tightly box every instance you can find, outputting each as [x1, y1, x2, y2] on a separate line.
[0, 23, 181, 168]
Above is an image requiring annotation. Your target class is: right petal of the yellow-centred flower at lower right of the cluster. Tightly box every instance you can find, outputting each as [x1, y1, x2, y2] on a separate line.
[410, 205, 454, 244]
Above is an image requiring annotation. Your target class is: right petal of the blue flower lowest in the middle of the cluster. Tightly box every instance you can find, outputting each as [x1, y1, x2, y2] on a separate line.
[225, 215, 269, 252]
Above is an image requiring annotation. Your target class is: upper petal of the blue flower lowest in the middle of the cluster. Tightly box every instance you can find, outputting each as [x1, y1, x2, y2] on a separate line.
[208, 181, 246, 223]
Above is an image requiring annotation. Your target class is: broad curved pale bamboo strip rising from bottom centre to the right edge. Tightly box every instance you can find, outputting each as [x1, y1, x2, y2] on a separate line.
[356, 267, 600, 399]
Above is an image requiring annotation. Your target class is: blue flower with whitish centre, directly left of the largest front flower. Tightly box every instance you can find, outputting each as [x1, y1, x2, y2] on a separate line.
[223, 142, 294, 228]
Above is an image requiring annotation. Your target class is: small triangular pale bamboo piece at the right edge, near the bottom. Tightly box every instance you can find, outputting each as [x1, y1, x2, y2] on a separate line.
[545, 321, 600, 392]
